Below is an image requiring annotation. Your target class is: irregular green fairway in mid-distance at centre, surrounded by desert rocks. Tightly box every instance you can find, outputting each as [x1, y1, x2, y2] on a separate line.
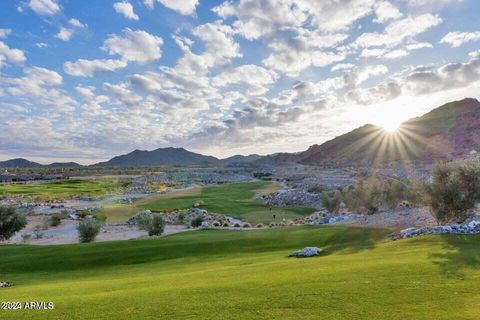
[139, 181, 315, 223]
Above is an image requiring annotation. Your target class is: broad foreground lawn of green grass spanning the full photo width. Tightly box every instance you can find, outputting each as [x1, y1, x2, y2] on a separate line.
[0, 227, 480, 320]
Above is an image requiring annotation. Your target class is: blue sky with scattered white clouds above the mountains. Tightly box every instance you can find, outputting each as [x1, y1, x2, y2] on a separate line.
[0, 0, 480, 164]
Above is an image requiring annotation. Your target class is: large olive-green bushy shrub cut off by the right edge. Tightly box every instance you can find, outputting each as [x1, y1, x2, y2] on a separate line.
[426, 162, 480, 223]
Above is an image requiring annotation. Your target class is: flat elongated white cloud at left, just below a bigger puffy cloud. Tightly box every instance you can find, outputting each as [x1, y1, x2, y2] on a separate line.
[63, 59, 127, 77]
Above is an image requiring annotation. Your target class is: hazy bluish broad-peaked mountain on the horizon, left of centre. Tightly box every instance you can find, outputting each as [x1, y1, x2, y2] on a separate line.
[95, 148, 220, 167]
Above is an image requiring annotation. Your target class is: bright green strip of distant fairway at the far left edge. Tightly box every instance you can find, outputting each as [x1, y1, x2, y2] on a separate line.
[0, 180, 118, 199]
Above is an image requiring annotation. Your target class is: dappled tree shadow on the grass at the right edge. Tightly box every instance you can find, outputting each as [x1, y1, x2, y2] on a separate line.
[429, 235, 480, 279]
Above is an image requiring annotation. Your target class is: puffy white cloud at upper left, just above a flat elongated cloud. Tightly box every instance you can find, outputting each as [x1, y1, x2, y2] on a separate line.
[102, 28, 163, 63]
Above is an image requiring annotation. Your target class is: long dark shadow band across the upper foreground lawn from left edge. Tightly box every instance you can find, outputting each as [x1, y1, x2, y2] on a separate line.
[0, 226, 389, 274]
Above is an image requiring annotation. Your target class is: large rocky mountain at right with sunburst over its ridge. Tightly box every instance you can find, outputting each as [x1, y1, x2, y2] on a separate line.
[288, 99, 480, 166]
